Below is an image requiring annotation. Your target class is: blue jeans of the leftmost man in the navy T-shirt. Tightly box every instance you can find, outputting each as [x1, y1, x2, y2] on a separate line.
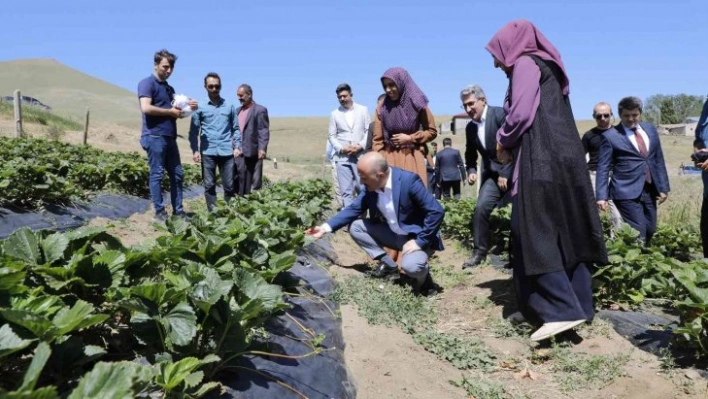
[140, 135, 184, 215]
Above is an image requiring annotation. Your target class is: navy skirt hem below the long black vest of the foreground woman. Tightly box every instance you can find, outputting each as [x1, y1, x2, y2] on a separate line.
[511, 199, 595, 323]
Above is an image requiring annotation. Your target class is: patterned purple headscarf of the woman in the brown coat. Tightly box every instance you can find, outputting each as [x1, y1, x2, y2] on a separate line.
[381, 67, 428, 143]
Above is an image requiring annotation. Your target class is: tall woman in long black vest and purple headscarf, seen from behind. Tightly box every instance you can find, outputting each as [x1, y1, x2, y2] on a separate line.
[486, 20, 608, 341]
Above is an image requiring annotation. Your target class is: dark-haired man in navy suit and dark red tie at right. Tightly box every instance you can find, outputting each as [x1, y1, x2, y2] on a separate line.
[596, 97, 670, 245]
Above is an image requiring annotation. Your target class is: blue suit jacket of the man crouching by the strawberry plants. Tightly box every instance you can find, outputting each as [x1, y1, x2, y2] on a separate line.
[327, 167, 445, 251]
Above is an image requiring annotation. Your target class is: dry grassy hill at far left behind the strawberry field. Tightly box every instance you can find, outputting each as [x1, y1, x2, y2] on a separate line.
[0, 59, 140, 127]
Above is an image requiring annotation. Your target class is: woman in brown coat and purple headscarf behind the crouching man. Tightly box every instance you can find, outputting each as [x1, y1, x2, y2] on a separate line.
[372, 68, 438, 186]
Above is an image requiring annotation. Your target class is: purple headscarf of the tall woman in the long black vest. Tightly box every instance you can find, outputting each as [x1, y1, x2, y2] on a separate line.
[485, 19, 570, 95]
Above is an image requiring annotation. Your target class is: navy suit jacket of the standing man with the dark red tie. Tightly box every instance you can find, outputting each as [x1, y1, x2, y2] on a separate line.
[595, 122, 670, 201]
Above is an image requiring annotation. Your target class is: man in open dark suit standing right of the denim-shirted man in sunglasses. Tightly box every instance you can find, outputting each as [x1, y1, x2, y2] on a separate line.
[236, 84, 270, 195]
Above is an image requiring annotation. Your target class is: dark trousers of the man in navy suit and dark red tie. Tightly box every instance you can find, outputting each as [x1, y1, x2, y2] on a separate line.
[614, 184, 658, 246]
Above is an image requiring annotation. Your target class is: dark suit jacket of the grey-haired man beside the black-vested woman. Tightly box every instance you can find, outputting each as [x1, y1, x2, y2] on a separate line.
[465, 105, 514, 184]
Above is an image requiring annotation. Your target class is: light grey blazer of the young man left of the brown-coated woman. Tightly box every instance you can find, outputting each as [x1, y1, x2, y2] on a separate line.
[329, 103, 371, 162]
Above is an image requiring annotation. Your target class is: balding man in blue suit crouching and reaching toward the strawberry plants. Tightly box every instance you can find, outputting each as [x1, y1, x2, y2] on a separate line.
[306, 152, 445, 294]
